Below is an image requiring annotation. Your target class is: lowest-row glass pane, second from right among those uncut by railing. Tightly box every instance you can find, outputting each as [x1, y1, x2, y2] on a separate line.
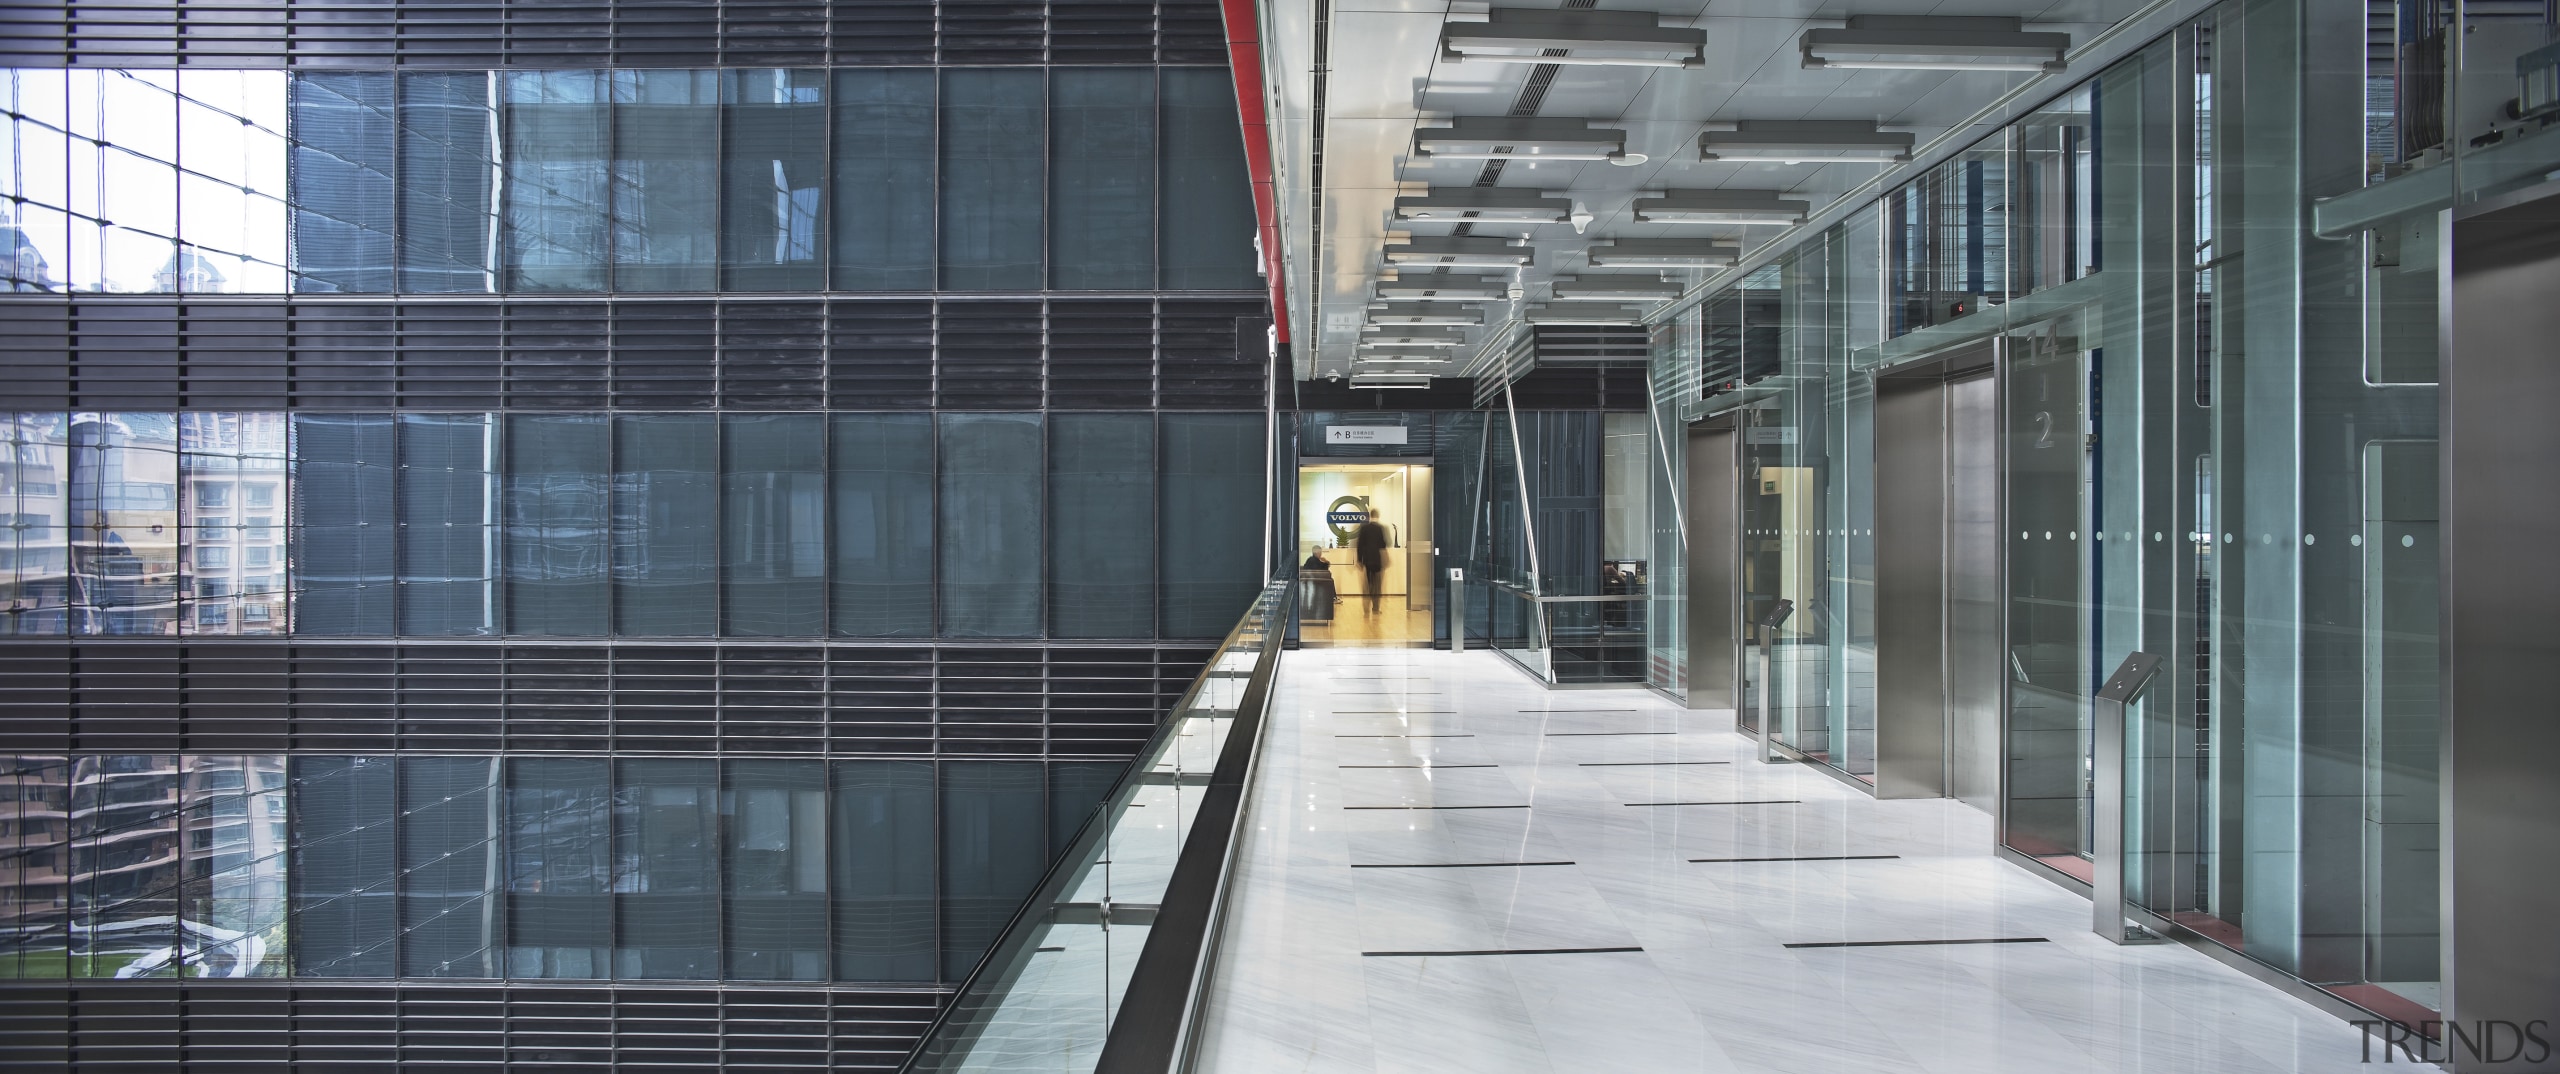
[719, 759, 829, 982]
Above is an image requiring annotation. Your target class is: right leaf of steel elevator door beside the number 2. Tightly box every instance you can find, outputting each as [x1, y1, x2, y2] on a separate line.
[1946, 373, 2002, 811]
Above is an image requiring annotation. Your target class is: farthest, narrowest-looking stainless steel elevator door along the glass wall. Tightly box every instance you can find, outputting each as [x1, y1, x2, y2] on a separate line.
[1687, 430, 1741, 708]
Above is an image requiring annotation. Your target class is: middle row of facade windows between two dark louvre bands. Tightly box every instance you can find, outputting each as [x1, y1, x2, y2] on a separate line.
[0, 412, 1269, 639]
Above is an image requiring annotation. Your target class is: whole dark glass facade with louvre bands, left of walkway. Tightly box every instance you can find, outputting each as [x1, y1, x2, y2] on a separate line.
[0, 3, 1275, 1069]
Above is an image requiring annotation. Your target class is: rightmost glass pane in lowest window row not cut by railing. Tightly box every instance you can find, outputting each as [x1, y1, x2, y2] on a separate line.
[827, 759, 940, 982]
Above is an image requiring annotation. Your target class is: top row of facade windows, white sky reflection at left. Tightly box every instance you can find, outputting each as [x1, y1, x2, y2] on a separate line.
[0, 66, 1260, 294]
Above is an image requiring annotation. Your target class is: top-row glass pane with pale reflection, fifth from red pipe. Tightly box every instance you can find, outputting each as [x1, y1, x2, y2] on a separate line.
[719, 69, 827, 292]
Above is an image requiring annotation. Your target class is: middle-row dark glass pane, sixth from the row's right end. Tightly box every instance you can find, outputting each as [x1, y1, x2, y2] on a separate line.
[612, 414, 719, 637]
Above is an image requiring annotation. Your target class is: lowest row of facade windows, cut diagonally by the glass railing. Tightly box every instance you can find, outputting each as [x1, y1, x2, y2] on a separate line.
[0, 754, 1121, 985]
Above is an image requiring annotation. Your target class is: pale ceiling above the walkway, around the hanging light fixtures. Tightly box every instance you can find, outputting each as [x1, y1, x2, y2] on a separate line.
[1262, 0, 2145, 378]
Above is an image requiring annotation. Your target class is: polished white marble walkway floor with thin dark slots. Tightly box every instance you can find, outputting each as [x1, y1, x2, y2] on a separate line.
[1201, 650, 2363, 1074]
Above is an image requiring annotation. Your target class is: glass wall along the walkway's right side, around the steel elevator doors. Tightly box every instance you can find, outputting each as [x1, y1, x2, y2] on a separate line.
[1649, 0, 2447, 1025]
